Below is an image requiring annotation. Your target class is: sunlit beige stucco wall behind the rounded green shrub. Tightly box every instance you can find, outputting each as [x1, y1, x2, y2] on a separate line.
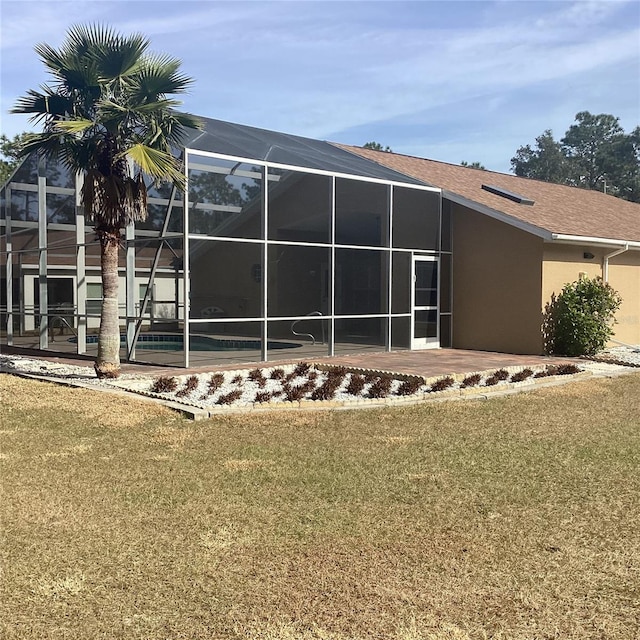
[542, 244, 640, 344]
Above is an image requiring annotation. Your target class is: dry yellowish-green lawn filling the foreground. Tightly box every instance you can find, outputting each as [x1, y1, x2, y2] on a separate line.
[0, 374, 640, 640]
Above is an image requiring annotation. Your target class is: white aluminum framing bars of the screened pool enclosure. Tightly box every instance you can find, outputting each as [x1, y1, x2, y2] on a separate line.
[2, 144, 442, 367]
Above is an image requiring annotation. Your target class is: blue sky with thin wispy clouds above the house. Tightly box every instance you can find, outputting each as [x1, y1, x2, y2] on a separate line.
[0, 0, 640, 172]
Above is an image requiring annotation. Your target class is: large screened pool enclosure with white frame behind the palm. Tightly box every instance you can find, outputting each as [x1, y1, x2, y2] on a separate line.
[0, 120, 451, 366]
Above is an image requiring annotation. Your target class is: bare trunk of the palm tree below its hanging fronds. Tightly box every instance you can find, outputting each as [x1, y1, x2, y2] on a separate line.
[94, 229, 120, 378]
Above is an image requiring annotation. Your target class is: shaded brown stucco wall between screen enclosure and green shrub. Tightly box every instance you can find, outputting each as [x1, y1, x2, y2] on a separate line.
[452, 205, 543, 354]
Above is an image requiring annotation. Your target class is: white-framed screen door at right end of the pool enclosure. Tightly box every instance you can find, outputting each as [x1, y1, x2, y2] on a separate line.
[411, 256, 440, 349]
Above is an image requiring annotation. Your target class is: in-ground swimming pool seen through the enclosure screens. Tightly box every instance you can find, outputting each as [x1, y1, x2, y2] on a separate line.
[69, 333, 302, 351]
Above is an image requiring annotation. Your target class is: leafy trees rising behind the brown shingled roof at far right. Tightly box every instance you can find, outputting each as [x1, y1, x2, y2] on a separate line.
[511, 111, 640, 202]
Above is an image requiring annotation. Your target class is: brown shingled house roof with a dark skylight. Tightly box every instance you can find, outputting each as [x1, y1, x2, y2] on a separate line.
[337, 145, 640, 248]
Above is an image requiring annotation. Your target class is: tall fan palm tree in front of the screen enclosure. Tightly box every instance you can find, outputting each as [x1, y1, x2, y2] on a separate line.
[12, 25, 201, 377]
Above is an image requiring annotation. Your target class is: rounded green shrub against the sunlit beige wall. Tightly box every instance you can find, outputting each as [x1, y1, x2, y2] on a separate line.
[542, 278, 622, 356]
